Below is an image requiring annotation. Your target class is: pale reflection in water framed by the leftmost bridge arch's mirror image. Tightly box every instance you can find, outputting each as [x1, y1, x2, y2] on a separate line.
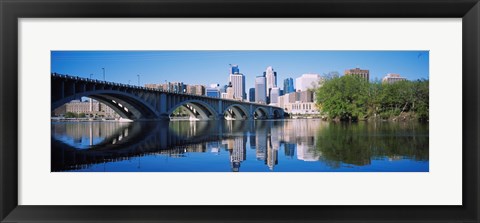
[52, 122, 130, 146]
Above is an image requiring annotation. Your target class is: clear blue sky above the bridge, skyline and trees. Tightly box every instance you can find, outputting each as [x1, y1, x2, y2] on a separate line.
[51, 50, 429, 89]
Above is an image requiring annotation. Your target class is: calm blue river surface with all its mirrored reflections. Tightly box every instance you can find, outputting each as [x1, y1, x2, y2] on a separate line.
[51, 119, 429, 172]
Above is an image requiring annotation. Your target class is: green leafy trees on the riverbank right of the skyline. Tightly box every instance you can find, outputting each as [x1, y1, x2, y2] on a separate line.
[314, 76, 429, 122]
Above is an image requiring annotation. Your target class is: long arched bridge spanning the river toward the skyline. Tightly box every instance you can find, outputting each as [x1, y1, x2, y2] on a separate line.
[51, 73, 284, 120]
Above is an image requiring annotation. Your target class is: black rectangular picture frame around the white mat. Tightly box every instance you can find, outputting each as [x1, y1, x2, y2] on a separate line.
[0, 0, 480, 222]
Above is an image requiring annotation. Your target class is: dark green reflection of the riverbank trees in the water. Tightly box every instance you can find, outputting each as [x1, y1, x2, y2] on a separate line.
[316, 122, 429, 167]
